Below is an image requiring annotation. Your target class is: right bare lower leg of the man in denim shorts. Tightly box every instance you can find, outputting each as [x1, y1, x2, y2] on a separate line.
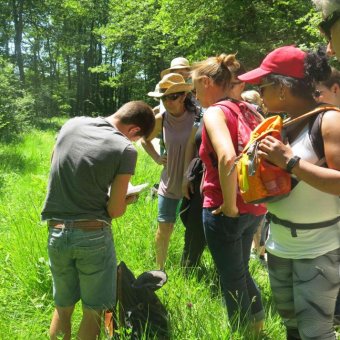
[77, 307, 103, 340]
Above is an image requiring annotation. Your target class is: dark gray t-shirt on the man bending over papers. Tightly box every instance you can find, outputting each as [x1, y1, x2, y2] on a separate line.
[41, 117, 137, 221]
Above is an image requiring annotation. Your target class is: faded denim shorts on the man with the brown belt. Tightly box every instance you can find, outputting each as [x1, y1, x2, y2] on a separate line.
[48, 227, 117, 310]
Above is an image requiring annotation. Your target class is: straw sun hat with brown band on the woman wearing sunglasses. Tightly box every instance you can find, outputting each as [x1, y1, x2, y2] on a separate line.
[148, 73, 193, 98]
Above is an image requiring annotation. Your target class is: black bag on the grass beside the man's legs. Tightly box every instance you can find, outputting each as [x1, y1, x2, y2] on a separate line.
[117, 262, 170, 339]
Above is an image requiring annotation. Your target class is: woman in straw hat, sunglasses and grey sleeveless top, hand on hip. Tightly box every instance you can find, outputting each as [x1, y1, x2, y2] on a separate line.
[142, 73, 196, 269]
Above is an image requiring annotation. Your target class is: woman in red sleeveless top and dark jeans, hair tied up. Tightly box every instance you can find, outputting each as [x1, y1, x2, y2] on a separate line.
[192, 54, 266, 331]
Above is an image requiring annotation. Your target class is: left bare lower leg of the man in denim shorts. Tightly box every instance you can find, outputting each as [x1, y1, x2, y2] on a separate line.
[50, 305, 74, 340]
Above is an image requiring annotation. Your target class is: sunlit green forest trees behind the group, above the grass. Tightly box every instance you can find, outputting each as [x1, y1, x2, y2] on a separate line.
[0, 0, 338, 139]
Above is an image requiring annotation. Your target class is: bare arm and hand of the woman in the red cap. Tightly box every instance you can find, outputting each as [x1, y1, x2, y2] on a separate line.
[259, 111, 340, 196]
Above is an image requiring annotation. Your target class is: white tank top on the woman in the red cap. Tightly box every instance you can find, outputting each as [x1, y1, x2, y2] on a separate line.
[266, 126, 340, 259]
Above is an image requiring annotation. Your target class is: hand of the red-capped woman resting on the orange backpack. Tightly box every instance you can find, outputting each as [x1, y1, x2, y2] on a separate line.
[258, 136, 294, 170]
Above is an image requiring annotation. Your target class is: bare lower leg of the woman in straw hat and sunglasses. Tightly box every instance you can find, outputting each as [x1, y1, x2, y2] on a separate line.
[155, 222, 174, 270]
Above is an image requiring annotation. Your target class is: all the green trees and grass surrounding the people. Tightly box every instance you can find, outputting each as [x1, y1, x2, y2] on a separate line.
[0, 0, 336, 340]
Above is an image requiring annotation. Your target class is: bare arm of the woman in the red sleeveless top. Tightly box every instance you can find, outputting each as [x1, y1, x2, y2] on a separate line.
[203, 107, 239, 217]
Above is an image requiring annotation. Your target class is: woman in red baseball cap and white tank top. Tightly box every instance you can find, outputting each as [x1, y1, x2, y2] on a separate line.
[239, 46, 340, 340]
